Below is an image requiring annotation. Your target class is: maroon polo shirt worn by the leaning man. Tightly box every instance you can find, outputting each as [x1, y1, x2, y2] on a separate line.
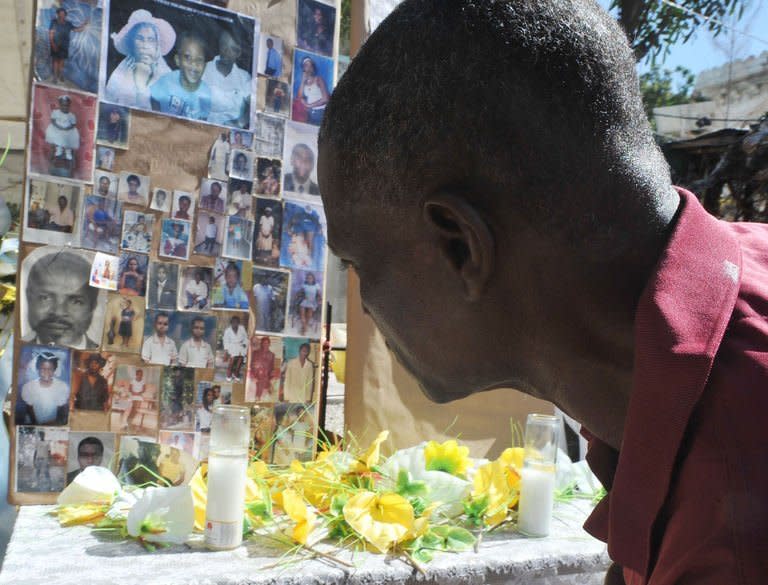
[585, 190, 768, 585]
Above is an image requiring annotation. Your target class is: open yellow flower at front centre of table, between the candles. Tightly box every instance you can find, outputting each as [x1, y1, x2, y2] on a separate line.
[344, 491, 414, 553]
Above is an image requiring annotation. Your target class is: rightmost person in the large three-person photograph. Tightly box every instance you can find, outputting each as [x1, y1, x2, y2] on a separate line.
[203, 30, 252, 128]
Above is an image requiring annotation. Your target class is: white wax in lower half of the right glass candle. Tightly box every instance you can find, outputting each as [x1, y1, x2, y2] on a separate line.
[517, 467, 555, 536]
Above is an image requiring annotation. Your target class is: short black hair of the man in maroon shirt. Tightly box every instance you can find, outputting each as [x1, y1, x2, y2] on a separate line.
[319, 0, 671, 245]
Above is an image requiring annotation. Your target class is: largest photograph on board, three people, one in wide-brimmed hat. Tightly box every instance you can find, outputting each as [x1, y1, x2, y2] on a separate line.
[100, 0, 259, 128]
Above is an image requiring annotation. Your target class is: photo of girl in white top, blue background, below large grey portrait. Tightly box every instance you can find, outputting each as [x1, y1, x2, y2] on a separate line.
[16, 344, 71, 426]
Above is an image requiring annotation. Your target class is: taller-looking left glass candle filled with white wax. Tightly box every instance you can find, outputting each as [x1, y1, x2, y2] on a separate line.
[205, 405, 250, 550]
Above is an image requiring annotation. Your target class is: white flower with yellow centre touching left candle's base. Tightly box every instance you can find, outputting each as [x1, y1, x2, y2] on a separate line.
[126, 486, 195, 544]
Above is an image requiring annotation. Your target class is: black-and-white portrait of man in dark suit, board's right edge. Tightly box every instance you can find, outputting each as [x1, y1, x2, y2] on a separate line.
[283, 122, 320, 201]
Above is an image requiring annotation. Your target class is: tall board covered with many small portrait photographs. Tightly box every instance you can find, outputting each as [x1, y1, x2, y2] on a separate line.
[12, 0, 337, 501]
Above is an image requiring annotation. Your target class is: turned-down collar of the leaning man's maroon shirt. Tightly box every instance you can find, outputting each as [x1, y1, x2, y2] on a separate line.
[585, 189, 741, 574]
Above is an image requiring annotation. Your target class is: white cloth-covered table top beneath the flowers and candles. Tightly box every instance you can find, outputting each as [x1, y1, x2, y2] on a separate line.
[0, 501, 610, 585]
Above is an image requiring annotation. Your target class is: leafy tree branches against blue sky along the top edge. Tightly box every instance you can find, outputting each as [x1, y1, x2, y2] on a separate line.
[611, 0, 750, 63]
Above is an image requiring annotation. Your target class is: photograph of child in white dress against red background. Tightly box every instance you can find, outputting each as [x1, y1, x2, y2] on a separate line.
[29, 85, 97, 181]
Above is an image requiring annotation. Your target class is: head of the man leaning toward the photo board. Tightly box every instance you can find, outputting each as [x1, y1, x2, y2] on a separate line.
[318, 0, 676, 400]
